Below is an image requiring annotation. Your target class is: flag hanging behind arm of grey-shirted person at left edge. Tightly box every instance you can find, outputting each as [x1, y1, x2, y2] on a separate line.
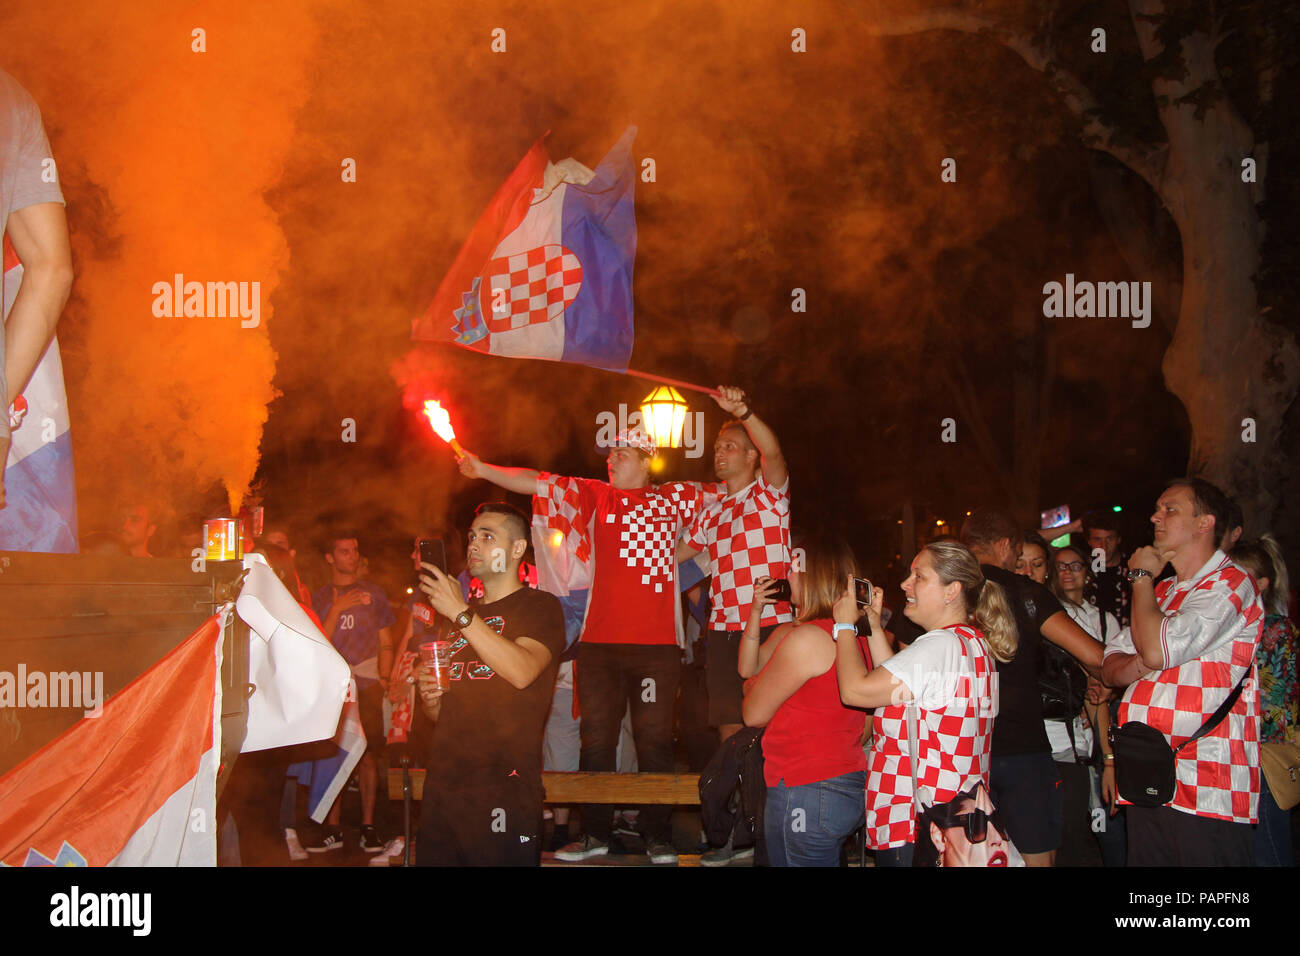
[0, 235, 77, 554]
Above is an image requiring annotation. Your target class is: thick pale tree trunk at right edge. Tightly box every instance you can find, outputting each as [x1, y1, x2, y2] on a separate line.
[1134, 22, 1300, 535]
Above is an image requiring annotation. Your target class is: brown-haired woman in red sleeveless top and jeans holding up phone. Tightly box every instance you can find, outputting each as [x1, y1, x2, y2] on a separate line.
[738, 541, 867, 866]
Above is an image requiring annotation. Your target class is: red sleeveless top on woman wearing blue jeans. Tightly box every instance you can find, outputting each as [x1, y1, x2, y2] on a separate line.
[763, 619, 871, 787]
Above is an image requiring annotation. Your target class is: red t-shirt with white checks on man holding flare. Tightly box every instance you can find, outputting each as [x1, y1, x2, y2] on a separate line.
[574, 479, 702, 645]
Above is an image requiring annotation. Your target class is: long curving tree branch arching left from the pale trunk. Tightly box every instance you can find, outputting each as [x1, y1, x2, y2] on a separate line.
[867, 7, 1167, 200]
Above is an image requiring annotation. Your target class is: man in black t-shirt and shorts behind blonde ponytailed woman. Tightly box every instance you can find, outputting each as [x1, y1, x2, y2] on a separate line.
[962, 509, 1105, 866]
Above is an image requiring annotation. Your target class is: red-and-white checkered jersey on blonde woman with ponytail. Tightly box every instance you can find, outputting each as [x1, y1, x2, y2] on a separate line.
[867, 624, 997, 849]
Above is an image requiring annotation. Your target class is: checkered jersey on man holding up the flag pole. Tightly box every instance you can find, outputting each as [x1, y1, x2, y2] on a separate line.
[686, 472, 794, 631]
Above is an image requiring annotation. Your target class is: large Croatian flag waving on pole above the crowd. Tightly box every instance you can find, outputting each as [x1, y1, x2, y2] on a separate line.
[411, 126, 637, 372]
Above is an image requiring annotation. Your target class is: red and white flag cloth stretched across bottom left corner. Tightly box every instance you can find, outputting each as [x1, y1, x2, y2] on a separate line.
[0, 613, 222, 866]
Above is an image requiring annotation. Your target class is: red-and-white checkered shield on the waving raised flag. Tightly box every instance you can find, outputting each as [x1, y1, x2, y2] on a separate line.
[480, 243, 582, 333]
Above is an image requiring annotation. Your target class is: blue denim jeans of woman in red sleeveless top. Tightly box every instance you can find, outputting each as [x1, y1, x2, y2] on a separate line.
[763, 770, 867, 866]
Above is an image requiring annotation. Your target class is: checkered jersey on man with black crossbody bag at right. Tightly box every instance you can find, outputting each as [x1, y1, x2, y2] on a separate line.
[1106, 551, 1264, 823]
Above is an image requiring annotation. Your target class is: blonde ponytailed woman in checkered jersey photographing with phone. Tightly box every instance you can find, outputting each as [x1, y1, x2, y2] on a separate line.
[835, 541, 1017, 866]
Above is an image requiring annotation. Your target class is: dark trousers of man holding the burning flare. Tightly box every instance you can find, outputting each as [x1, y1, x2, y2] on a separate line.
[576, 644, 681, 843]
